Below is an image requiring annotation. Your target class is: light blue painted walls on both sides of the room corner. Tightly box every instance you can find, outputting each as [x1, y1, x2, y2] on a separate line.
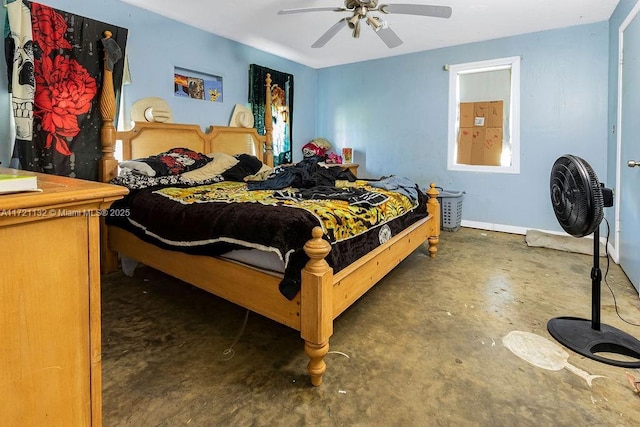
[0, 0, 616, 231]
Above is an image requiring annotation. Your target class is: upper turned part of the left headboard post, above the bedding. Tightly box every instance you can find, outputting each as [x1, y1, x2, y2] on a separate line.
[98, 31, 118, 182]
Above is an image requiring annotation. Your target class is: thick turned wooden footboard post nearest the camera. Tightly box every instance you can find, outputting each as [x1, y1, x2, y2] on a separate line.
[300, 227, 333, 386]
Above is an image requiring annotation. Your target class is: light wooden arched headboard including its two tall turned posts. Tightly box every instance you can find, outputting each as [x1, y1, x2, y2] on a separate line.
[98, 31, 273, 182]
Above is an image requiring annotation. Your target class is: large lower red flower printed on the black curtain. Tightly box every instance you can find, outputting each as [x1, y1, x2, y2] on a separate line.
[34, 55, 98, 155]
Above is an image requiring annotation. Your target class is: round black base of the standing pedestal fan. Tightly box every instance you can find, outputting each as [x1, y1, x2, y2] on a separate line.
[547, 317, 640, 368]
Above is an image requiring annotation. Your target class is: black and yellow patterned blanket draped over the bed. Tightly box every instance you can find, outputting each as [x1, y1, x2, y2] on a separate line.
[107, 182, 427, 299]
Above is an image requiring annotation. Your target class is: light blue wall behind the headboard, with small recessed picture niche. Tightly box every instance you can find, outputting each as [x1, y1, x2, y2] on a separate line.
[0, 0, 317, 166]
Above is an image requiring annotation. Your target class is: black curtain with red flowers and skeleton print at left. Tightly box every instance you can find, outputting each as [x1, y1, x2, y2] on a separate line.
[5, 0, 128, 180]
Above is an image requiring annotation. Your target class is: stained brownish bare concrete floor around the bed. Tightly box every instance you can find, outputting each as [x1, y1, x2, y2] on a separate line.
[102, 228, 640, 426]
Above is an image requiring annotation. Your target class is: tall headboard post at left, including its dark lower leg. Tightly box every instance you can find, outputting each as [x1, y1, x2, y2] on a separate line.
[98, 31, 118, 273]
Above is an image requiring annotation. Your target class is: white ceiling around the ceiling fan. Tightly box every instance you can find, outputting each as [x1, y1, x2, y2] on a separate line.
[122, 0, 619, 68]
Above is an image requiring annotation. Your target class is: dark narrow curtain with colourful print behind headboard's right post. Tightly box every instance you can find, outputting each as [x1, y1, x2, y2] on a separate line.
[249, 64, 293, 165]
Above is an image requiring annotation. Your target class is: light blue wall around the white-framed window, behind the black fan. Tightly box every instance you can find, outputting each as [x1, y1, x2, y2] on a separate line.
[318, 22, 609, 231]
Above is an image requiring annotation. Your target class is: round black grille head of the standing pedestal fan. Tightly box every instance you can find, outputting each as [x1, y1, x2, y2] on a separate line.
[550, 154, 604, 237]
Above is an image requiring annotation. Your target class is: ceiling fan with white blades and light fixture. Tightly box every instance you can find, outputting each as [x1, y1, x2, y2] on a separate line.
[278, 0, 451, 48]
